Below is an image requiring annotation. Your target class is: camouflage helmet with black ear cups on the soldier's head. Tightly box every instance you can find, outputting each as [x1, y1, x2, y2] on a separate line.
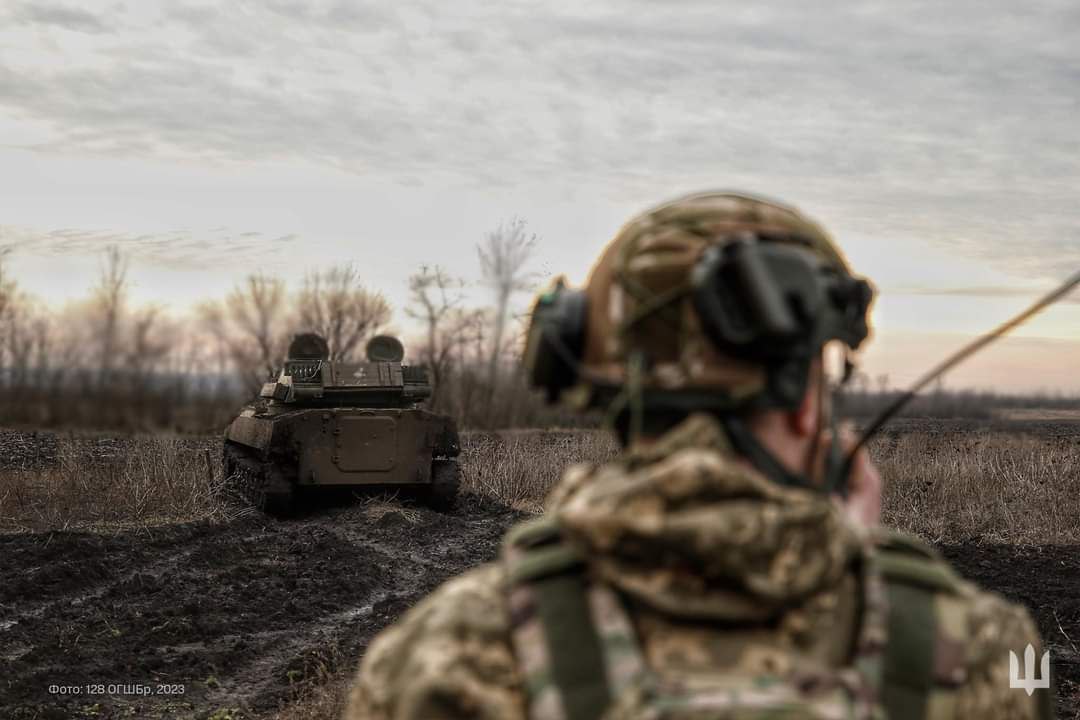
[526, 192, 872, 416]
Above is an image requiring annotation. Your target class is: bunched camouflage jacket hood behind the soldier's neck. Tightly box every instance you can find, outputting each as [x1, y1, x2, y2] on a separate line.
[549, 415, 865, 621]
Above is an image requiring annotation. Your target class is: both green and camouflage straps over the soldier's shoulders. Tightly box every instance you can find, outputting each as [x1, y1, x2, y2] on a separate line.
[503, 516, 1002, 720]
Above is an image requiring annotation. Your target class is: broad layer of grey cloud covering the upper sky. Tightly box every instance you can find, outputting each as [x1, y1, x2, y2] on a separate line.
[0, 0, 1080, 280]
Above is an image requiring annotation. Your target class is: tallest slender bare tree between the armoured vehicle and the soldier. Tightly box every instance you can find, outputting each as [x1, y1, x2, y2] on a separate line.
[476, 217, 537, 395]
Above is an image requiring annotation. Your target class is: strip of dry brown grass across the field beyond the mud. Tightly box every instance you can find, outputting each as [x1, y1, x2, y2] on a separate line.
[8, 431, 1080, 544]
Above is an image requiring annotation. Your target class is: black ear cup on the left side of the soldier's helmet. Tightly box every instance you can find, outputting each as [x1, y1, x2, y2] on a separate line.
[525, 284, 588, 403]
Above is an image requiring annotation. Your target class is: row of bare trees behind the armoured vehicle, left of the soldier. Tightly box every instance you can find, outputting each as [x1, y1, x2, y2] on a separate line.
[0, 218, 587, 432]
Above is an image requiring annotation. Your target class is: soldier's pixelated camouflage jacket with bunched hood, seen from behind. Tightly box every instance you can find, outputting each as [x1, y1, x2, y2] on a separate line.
[345, 416, 1049, 720]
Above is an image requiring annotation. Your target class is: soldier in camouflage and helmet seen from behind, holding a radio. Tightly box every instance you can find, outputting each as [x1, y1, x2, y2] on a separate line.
[346, 193, 1051, 720]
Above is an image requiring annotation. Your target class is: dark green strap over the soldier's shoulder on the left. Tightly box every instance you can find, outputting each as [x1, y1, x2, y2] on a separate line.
[503, 517, 611, 720]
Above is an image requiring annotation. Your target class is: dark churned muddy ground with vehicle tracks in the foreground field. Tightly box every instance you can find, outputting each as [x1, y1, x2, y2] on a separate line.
[0, 423, 1080, 720]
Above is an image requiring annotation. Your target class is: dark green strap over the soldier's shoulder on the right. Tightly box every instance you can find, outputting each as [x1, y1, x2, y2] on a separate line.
[877, 530, 966, 720]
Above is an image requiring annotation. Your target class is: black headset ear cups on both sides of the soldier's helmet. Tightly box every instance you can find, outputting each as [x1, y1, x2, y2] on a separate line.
[527, 234, 874, 407]
